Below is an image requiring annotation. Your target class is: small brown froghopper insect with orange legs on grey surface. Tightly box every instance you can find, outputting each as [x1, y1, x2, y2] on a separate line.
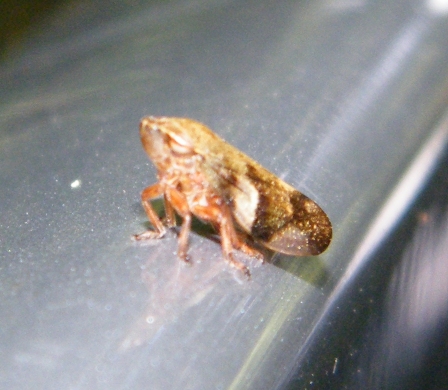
[133, 116, 332, 277]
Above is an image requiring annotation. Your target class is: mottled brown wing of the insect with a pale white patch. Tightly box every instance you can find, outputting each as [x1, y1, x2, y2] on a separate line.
[203, 150, 332, 256]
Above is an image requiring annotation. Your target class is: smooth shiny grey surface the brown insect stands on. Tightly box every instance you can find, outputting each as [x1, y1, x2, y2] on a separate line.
[0, 0, 448, 389]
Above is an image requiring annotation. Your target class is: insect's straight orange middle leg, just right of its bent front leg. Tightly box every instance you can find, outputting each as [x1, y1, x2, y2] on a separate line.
[166, 188, 192, 263]
